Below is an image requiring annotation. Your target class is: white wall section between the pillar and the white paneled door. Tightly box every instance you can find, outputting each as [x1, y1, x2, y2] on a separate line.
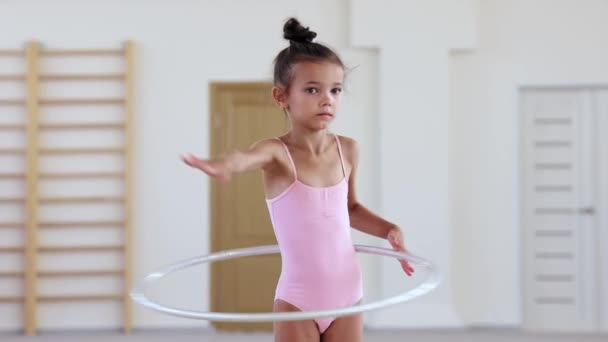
[450, 0, 608, 325]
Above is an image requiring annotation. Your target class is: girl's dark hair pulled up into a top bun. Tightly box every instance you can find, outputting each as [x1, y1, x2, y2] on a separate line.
[274, 18, 344, 88]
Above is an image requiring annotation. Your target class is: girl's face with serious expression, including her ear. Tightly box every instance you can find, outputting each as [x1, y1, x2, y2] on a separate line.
[273, 62, 344, 131]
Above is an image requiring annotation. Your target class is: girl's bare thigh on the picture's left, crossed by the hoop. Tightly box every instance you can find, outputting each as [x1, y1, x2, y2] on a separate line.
[274, 299, 320, 342]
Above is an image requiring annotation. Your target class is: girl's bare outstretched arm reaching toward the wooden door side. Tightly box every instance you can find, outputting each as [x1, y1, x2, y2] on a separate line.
[181, 139, 277, 181]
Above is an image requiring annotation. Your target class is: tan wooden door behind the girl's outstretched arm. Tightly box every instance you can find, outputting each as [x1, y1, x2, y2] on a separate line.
[209, 83, 287, 330]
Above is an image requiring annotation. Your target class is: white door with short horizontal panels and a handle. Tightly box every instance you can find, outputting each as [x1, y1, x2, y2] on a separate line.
[520, 88, 608, 332]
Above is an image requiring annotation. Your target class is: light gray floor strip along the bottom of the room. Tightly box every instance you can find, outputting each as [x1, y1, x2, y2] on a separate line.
[0, 329, 608, 342]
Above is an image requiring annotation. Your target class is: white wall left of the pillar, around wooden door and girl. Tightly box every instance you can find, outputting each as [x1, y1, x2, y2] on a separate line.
[0, 0, 379, 330]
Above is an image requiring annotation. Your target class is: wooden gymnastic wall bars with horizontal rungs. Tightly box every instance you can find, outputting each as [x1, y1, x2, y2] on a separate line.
[0, 41, 134, 335]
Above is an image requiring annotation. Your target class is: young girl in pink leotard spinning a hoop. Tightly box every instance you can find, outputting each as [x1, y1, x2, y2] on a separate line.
[183, 18, 414, 342]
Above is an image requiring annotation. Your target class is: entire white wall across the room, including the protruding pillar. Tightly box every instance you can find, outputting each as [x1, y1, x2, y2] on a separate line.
[0, 0, 608, 329]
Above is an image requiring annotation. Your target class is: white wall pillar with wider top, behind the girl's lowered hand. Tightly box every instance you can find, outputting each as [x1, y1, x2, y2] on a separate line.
[351, 0, 477, 327]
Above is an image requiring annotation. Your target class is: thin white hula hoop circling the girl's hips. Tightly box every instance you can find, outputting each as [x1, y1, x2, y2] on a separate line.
[131, 245, 441, 322]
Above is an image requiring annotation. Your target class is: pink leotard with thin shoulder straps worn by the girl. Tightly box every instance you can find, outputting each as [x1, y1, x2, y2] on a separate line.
[266, 136, 363, 333]
